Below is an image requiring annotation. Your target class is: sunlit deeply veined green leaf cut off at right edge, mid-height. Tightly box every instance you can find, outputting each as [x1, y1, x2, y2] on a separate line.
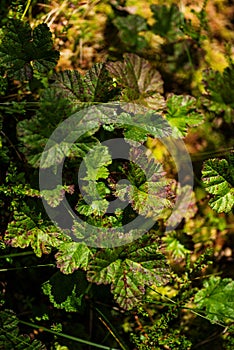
[202, 154, 234, 213]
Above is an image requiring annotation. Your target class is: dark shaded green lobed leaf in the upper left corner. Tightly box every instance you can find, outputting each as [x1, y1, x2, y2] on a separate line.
[0, 18, 59, 80]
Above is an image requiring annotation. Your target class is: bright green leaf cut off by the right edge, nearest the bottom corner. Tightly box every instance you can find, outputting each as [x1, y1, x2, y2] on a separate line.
[194, 276, 234, 322]
